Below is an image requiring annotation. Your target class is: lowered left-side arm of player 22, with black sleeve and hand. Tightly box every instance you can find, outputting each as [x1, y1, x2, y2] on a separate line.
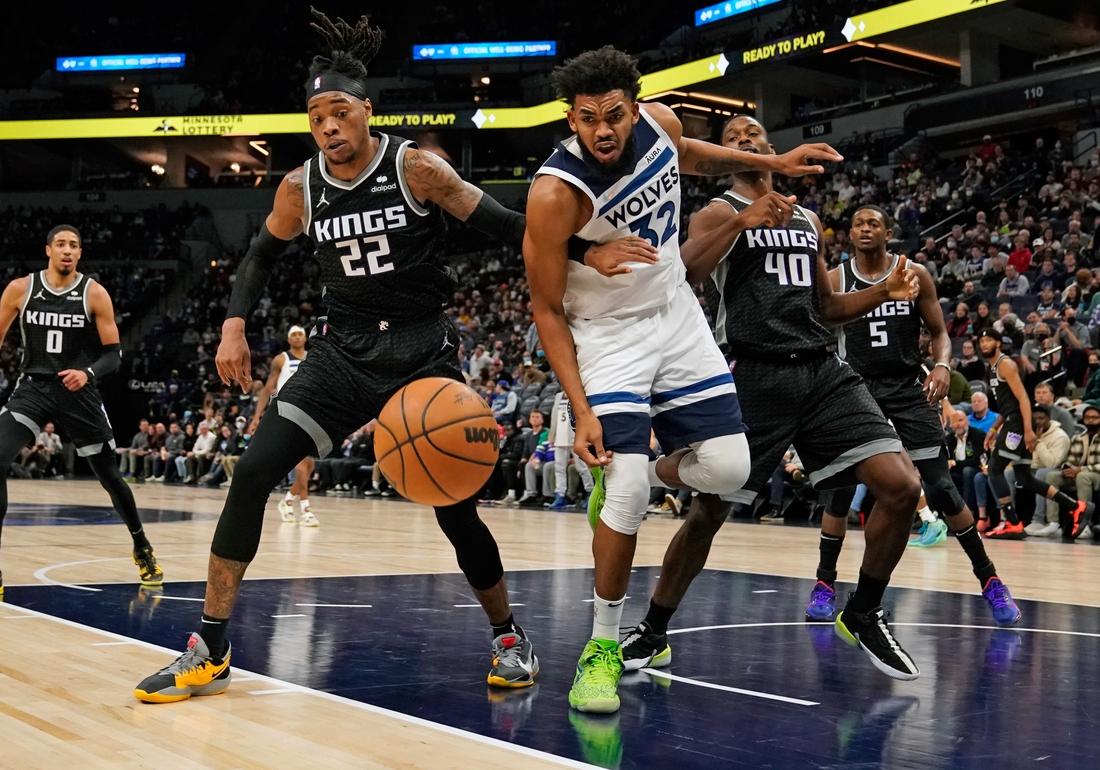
[215, 167, 306, 391]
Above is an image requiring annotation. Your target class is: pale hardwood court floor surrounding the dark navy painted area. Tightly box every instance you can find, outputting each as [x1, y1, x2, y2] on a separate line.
[0, 481, 1100, 769]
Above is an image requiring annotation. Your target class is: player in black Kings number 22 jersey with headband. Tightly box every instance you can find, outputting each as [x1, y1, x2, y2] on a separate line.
[134, 11, 538, 703]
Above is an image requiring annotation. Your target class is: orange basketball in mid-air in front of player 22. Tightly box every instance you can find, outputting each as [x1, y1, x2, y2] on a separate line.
[374, 377, 499, 506]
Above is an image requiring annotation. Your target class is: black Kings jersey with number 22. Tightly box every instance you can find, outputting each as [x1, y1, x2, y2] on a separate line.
[304, 132, 457, 329]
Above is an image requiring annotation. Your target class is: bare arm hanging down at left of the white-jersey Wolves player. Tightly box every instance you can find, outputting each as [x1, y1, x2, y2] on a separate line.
[524, 176, 611, 465]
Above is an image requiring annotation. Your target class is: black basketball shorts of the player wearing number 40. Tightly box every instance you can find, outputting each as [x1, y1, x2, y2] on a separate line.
[726, 354, 902, 503]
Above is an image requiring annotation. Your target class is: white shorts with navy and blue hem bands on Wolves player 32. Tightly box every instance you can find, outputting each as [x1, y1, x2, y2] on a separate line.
[569, 283, 745, 454]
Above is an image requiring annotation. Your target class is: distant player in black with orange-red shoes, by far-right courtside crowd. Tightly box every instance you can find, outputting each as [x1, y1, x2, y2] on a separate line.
[978, 329, 1096, 540]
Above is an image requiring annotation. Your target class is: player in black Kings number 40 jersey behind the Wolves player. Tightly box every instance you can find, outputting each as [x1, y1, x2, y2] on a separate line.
[607, 116, 921, 680]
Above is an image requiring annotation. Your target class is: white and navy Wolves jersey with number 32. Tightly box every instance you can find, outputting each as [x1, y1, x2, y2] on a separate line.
[538, 109, 685, 319]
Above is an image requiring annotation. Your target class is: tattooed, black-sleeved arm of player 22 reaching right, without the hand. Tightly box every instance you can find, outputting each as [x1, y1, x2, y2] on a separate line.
[403, 147, 526, 248]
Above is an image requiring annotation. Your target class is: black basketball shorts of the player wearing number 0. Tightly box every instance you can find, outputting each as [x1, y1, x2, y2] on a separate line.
[0, 374, 114, 458]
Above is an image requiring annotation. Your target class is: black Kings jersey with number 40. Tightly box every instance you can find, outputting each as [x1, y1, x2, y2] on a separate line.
[711, 190, 833, 361]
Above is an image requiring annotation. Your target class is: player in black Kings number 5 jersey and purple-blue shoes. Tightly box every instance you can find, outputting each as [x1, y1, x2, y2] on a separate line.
[806, 206, 1021, 626]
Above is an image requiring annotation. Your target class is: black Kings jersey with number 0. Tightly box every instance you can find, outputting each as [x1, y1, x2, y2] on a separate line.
[19, 272, 102, 375]
